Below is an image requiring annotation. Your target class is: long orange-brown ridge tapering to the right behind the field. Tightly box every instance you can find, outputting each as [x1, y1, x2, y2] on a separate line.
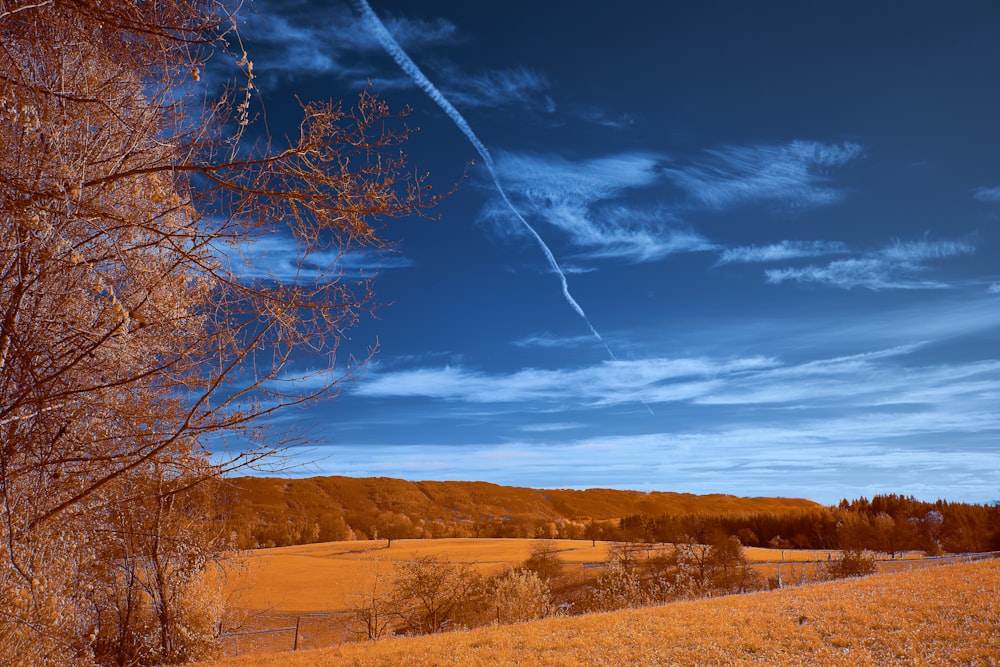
[223, 477, 821, 547]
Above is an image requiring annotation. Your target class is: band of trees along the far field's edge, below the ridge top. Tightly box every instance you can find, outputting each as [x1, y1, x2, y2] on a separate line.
[227, 494, 1000, 555]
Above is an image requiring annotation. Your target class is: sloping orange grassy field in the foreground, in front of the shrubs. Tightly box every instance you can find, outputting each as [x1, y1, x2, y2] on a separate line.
[207, 560, 1000, 667]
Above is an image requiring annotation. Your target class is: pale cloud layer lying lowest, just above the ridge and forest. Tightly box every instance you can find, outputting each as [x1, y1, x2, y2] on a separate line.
[300, 410, 1000, 505]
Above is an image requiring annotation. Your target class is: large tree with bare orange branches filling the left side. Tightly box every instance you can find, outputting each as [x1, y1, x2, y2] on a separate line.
[0, 0, 446, 666]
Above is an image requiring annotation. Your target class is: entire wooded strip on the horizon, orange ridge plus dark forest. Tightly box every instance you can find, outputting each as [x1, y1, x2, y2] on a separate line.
[225, 477, 1000, 555]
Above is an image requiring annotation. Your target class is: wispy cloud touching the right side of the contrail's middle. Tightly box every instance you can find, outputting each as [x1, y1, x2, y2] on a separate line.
[483, 153, 713, 262]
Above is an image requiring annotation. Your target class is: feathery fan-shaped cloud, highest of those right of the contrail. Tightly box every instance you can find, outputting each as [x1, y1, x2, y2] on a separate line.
[664, 141, 864, 209]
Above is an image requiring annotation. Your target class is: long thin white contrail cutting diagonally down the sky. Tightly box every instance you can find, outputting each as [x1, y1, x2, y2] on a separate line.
[356, 0, 615, 344]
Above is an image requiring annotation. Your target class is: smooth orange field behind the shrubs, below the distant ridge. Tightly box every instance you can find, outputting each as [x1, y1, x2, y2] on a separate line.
[223, 539, 968, 656]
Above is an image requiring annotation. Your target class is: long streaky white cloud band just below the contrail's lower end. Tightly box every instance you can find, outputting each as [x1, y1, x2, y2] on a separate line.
[355, 336, 1000, 420]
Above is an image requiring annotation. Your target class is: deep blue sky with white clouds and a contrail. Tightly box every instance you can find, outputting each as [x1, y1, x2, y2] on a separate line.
[229, 0, 1000, 504]
